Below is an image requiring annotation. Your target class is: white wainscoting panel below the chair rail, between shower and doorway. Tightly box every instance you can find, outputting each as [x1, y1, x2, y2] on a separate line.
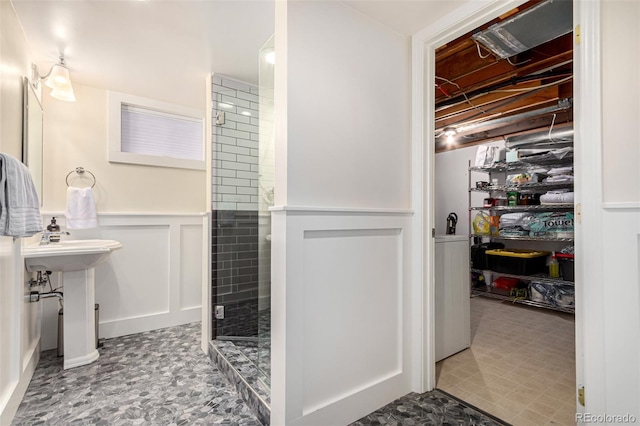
[271, 207, 412, 425]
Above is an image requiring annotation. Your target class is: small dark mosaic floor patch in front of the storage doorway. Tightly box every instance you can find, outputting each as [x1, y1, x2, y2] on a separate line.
[350, 389, 508, 426]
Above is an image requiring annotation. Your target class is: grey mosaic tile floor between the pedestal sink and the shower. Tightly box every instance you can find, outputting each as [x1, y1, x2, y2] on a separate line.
[13, 323, 260, 425]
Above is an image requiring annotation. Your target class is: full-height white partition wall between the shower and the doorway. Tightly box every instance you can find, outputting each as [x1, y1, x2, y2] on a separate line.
[271, 1, 412, 425]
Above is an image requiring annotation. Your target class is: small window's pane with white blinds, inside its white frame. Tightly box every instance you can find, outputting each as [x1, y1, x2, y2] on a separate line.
[121, 105, 204, 160]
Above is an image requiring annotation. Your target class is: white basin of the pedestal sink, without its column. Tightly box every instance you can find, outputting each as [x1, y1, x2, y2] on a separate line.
[22, 240, 122, 272]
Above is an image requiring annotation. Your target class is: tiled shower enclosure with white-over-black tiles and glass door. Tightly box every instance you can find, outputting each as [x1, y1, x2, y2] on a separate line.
[211, 67, 273, 410]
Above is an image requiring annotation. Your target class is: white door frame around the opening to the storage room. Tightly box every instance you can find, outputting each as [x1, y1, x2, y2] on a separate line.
[411, 0, 604, 411]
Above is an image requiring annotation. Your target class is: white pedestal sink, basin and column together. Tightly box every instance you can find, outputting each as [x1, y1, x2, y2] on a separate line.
[22, 240, 122, 369]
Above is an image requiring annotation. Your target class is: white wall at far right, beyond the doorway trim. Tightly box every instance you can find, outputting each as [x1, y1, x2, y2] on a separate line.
[583, 1, 640, 418]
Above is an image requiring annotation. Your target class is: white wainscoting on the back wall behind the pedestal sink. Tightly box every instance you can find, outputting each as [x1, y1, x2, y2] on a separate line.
[42, 213, 207, 349]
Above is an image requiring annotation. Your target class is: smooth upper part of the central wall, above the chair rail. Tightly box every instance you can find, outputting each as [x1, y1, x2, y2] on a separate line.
[284, 2, 410, 208]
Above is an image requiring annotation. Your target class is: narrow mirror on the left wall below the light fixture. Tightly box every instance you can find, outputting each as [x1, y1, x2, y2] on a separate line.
[22, 77, 44, 205]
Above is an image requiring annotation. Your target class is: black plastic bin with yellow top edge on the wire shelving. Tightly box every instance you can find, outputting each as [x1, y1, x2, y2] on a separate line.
[485, 249, 549, 275]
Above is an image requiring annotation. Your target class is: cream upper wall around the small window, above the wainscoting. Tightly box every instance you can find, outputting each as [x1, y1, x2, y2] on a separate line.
[43, 80, 207, 213]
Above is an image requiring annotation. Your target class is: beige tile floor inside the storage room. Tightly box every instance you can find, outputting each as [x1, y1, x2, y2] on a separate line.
[436, 297, 575, 426]
